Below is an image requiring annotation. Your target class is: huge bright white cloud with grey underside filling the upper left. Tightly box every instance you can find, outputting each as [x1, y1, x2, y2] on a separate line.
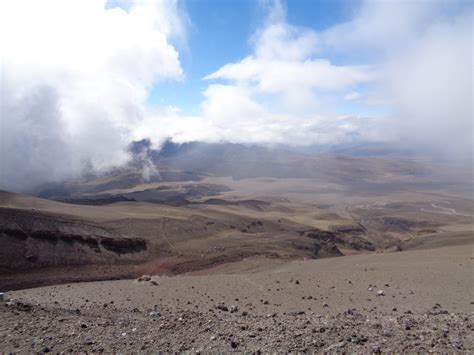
[0, 0, 184, 189]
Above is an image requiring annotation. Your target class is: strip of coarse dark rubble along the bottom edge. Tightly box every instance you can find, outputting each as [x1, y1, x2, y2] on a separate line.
[0, 302, 474, 353]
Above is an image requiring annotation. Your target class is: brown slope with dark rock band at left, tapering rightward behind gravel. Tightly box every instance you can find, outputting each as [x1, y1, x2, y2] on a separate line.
[0, 186, 376, 289]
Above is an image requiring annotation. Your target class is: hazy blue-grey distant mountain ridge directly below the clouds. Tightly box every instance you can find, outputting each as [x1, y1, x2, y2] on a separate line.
[33, 139, 468, 198]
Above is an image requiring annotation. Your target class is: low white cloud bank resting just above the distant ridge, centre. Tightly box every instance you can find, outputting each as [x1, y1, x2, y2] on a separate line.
[136, 89, 386, 152]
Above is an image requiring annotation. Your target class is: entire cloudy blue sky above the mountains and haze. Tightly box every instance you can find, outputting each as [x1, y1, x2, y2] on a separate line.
[0, 0, 473, 191]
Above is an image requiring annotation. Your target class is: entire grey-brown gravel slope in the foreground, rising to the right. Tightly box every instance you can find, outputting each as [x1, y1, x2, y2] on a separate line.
[0, 246, 474, 353]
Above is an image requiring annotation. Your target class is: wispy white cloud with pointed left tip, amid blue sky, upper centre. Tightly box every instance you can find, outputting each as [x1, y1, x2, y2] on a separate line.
[205, 1, 375, 112]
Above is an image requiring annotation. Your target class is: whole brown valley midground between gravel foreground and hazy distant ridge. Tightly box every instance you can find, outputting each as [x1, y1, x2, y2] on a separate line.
[0, 164, 473, 289]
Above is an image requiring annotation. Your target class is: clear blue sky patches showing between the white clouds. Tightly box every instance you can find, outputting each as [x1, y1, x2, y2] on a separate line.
[148, 0, 362, 115]
